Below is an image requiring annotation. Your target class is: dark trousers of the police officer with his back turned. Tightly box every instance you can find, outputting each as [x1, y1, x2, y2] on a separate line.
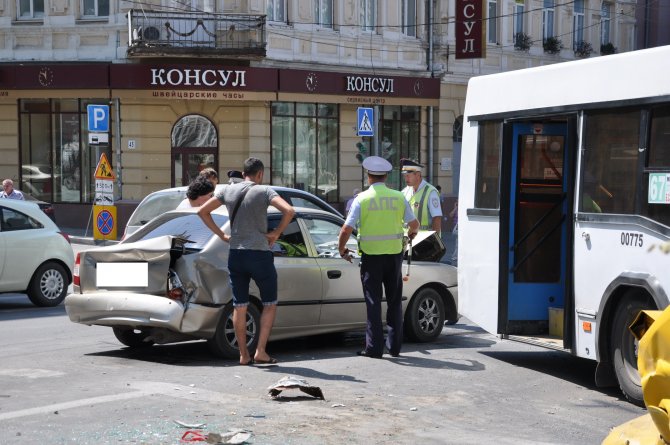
[361, 253, 403, 357]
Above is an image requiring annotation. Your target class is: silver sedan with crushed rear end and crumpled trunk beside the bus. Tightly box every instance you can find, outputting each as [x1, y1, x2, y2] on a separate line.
[65, 206, 458, 358]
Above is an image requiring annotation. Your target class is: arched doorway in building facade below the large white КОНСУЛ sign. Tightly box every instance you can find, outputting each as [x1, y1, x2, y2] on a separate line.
[171, 114, 219, 187]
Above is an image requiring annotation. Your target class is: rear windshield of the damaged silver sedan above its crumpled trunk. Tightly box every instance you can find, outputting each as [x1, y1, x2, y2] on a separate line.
[138, 213, 228, 250]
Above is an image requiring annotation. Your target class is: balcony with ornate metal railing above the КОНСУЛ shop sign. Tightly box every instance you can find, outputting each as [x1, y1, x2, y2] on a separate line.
[127, 9, 267, 59]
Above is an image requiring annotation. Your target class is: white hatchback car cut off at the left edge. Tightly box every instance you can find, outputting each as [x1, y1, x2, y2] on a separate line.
[0, 199, 74, 306]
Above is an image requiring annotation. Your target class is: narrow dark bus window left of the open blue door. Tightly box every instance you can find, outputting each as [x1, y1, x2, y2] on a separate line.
[475, 121, 502, 209]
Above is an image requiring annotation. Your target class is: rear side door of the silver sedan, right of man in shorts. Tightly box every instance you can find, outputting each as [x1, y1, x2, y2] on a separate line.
[268, 214, 322, 336]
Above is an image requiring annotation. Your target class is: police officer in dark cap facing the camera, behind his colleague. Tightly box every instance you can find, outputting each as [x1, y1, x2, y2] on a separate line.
[400, 159, 442, 236]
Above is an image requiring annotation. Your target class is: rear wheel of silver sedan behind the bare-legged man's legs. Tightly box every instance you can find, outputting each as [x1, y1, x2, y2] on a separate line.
[207, 304, 261, 359]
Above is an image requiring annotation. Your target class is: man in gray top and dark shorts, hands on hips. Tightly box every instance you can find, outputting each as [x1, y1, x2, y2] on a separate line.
[198, 158, 295, 365]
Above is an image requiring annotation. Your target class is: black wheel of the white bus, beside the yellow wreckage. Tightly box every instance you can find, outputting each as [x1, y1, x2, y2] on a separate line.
[611, 297, 650, 407]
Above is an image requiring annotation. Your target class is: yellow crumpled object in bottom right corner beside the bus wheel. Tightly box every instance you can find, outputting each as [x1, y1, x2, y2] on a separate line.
[603, 307, 670, 445]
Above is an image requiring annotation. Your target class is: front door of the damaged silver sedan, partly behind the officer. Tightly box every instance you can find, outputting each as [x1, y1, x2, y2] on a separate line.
[301, 215, 365, 329]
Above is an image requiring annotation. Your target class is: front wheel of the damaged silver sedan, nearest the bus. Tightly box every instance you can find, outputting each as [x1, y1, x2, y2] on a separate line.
[405, 288, 444, 342]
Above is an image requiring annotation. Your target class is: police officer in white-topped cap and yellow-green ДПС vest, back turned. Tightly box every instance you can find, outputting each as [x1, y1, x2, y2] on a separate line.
[339, 156, 419, 358]
